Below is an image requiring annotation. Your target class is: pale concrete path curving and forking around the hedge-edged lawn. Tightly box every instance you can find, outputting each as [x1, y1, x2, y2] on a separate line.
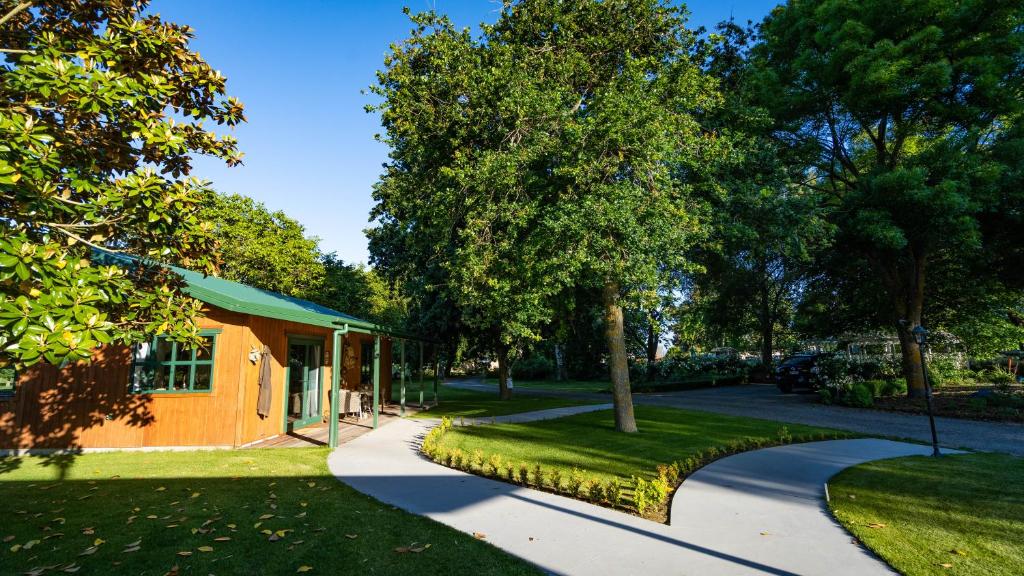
[328, 409, 942, 576]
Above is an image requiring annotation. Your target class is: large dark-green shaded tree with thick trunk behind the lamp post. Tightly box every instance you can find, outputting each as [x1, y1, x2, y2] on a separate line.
[756, 0, 1024, 396]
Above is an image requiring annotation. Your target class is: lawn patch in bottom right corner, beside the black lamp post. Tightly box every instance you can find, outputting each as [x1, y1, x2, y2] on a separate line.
[828, 454, 1024, 576]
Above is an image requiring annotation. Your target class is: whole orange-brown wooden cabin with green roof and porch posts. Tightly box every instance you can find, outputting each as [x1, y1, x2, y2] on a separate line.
[0, 258, 417, 451]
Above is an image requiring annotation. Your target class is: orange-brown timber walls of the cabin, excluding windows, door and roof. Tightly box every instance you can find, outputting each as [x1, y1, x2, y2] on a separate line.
[0, 307, 391, 449]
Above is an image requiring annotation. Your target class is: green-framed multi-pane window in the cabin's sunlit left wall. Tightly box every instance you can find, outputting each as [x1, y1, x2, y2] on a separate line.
[131, 333, 216, 393]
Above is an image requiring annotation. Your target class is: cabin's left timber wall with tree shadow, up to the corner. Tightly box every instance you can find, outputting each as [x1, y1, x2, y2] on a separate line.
[0, 310, 246, 448]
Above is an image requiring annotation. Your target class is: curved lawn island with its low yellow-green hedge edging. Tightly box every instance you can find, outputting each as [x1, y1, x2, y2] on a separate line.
[421, 406, 854, 523]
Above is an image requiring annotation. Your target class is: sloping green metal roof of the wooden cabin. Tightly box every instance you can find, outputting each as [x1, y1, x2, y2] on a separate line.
[93, 250, 387, 332]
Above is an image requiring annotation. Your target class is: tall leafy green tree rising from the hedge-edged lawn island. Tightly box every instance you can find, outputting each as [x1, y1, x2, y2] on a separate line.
[372, 0, 718, 431]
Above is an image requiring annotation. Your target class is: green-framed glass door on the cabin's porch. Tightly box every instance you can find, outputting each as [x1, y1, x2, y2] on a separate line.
[285, 338, 323, 430]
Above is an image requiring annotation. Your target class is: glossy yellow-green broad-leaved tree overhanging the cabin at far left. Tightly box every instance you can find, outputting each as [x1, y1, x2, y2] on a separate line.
[0, 0, 244, 364]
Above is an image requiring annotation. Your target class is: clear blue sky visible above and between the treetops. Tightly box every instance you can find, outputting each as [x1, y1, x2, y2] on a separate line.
[151, 0, 778, 262]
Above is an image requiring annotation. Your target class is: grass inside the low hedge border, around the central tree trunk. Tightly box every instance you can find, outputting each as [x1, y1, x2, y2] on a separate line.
[439, 406, 845, 482]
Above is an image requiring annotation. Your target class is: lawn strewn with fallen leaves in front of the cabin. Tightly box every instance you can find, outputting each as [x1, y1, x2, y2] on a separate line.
[0, 449, 537, 576]
